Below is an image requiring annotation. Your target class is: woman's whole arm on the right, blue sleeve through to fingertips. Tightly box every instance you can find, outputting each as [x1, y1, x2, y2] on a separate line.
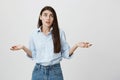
[61, 31, 92, 58]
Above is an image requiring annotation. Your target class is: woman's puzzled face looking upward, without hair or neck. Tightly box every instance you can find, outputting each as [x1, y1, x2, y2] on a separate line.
[40, 10, 54, 28]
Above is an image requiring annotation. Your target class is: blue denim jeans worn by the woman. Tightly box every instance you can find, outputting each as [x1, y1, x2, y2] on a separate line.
[32, 63, 63, 80]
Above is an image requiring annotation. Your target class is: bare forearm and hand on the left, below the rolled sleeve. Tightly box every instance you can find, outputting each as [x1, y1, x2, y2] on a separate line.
[10, 45, 32, 58]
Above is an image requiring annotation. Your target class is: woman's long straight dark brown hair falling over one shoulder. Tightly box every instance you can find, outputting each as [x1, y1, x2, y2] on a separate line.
[37, 6, 61, 53]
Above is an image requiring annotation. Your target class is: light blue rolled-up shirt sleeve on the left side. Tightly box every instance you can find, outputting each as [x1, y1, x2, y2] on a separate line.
[29, 36, 36, 60]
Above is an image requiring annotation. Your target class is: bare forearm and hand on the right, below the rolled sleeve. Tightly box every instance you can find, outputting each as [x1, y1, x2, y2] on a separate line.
[69, 42, 92, 56]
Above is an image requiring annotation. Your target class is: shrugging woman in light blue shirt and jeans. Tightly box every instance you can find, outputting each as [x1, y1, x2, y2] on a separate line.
[11, 6, 92, 80]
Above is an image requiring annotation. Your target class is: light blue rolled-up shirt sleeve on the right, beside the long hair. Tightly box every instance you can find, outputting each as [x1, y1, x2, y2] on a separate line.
[61, 31, 72, 59]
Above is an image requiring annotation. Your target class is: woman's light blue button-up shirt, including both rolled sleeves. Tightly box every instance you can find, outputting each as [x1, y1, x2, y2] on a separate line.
[29, 28, 71, 66]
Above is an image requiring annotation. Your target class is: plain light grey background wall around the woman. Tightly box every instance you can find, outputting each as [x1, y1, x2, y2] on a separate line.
[0, 0, 120, 80]
